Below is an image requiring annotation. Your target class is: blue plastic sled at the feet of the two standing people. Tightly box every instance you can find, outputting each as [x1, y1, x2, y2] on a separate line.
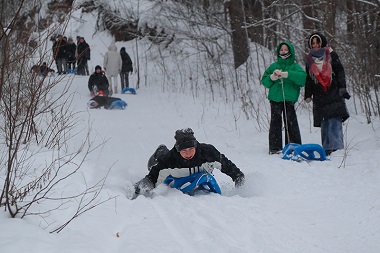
[282, 143, 327, 161]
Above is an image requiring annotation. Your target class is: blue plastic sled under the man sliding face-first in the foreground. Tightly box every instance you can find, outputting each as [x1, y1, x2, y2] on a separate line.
[164, 172, 222, 195]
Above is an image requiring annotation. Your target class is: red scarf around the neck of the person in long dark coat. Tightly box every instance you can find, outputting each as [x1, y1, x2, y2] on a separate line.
[307, 47, 332, 92]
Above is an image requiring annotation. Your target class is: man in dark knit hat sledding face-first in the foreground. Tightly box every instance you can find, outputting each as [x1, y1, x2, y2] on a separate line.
[134, 128, 245, 196]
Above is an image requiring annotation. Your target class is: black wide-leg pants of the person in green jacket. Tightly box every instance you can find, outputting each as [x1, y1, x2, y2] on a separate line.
[269, 101, 302, 151]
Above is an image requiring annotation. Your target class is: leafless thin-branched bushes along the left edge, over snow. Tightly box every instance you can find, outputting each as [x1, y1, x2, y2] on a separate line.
[0, 1, 114, 232]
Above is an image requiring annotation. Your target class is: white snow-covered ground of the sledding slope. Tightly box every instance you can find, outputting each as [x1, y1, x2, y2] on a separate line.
[0, 4, 380, 253]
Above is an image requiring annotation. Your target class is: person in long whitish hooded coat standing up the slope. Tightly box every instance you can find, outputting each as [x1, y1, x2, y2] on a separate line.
[103, 43, 122, 94]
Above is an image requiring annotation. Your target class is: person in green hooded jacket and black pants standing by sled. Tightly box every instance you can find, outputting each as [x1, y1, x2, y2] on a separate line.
[261, 42, 306, 154]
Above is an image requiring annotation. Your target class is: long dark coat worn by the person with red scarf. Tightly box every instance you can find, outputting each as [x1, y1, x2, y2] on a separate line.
[305, 51, 350, 127]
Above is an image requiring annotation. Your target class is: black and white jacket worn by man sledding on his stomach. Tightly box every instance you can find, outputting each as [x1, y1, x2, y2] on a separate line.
[146, 143, 244, 184]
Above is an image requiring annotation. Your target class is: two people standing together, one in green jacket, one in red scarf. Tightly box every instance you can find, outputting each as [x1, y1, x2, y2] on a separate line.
[261, 33, 350, 155]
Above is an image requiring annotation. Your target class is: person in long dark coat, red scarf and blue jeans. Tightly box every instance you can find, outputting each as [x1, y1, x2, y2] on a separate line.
[305, 33, 350, 155]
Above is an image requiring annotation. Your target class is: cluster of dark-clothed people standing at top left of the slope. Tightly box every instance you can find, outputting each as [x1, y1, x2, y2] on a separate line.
[51, 35, 91, 75]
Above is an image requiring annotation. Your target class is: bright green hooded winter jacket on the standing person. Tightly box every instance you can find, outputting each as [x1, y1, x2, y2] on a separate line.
[261, 42, 306, 102]
